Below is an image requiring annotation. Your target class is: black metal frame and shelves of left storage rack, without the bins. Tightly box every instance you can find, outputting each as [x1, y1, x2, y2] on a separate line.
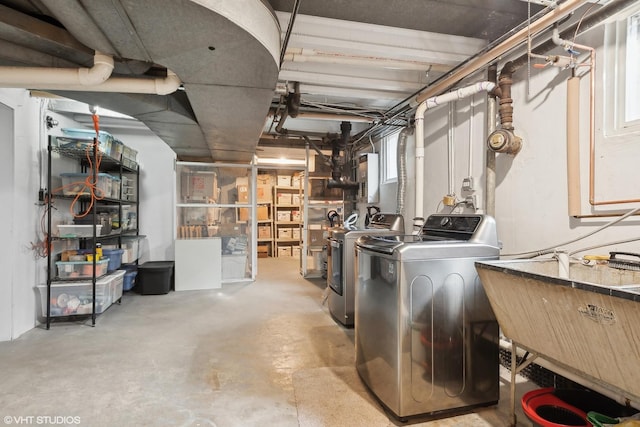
[45, 136, 140, 329]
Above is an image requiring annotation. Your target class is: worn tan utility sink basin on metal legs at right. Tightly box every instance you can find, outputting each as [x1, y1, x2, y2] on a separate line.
[476, 259, 640, 406]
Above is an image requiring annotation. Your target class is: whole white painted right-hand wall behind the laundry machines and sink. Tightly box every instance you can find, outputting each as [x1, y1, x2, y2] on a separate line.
[410, 22, 640, 254]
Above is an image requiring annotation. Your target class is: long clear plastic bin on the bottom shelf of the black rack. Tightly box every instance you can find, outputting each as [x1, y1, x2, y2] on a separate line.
[38, 277, 113, 317]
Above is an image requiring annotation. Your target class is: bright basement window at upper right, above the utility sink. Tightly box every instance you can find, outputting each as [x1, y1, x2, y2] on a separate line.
[604, 5, 640, 136]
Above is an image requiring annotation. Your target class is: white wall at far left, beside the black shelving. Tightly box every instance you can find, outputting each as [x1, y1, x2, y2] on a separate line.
[0, 89, 46, 341]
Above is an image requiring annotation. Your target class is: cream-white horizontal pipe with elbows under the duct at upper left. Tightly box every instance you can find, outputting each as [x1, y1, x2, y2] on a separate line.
[0, 52, 181, 95]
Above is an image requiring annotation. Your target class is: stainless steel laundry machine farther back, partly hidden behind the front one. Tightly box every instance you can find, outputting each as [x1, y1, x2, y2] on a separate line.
[327, 213, 404, 327]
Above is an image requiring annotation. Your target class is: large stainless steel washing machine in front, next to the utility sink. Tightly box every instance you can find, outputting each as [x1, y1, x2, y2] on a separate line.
[355, 214, 499, 419]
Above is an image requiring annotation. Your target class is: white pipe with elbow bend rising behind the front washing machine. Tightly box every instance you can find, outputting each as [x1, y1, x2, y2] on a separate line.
[415, 81, 496, 218]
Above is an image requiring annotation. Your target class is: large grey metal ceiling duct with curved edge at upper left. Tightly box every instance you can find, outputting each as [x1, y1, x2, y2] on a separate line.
[0, 0, 280, 163]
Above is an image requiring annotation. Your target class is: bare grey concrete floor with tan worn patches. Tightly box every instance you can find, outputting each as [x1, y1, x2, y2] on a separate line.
[0, 258, 537, 427]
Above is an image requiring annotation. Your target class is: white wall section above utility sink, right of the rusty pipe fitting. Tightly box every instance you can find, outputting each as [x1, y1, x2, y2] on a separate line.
[496, 27, 640, 254]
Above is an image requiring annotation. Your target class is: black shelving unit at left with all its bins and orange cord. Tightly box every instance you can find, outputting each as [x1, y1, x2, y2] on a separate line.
[45, 135, 140, 329]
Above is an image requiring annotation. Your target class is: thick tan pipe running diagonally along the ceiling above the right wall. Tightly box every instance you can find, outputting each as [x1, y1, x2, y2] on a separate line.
[411, 0, 587, 107]
